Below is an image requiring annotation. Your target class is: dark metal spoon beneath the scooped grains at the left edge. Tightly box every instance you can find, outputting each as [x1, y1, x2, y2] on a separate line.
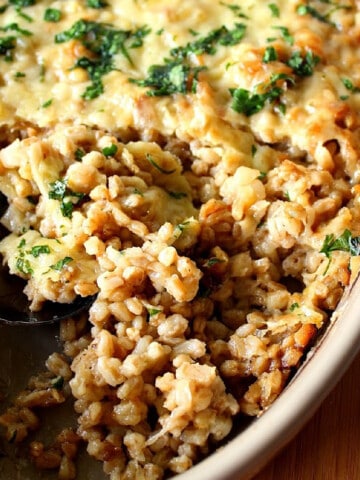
[0, 193, 96, 325]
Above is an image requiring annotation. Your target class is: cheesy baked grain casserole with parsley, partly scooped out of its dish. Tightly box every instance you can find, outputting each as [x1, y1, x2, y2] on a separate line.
[0, 0, 360, 480]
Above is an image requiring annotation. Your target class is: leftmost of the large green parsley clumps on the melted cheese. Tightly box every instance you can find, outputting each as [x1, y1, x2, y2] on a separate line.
[55, 20, 151, 100]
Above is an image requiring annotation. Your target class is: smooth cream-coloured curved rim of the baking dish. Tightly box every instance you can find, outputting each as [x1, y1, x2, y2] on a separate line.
[176, 274, 360, 480]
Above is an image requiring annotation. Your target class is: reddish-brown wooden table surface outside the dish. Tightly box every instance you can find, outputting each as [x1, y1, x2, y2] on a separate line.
[253, 348, 360, 480]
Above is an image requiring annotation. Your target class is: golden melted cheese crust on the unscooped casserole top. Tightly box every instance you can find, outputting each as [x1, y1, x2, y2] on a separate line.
[0, 0, 359, 152]
